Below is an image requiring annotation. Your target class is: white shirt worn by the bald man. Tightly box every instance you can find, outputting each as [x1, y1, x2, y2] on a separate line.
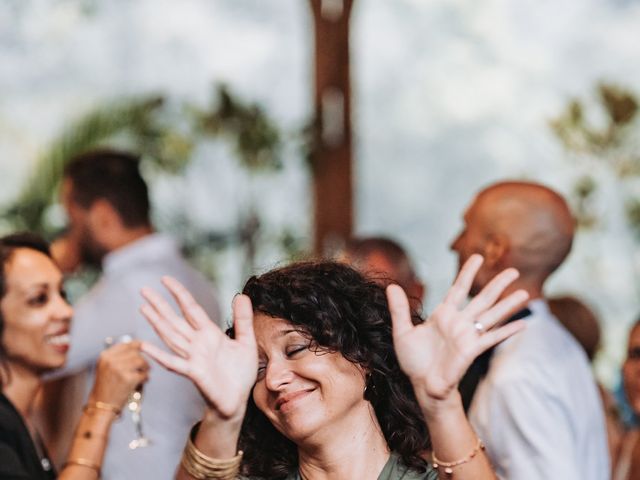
[469, 300, 610, 480]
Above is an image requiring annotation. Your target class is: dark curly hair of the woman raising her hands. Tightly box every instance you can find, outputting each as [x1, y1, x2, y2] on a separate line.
[235, 262, 429, 479]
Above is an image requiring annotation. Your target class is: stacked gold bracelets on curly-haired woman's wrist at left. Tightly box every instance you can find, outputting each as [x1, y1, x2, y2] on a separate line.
[180, 423, 242, 480]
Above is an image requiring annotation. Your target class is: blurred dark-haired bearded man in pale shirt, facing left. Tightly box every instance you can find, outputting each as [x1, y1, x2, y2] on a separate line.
[44, 150, 219, 480]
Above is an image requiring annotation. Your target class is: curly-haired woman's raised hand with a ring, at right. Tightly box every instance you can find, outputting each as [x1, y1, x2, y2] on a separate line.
[387, 255, 529, 400]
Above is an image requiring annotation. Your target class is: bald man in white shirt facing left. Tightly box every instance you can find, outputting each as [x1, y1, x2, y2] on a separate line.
[451, 182, 610, 480]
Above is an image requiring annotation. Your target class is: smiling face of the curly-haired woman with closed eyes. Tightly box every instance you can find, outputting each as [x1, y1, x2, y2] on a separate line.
[253, 314, 374, 445]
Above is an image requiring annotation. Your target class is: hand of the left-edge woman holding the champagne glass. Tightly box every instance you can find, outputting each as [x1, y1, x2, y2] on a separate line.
[90, 341, 149, 409]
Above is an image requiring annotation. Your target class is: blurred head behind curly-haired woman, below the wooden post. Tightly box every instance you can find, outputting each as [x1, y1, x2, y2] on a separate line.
[339, 237, 426, 312]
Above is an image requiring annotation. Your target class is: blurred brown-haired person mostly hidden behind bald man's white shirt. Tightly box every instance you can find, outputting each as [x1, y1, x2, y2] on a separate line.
[548, 295, 623, 474]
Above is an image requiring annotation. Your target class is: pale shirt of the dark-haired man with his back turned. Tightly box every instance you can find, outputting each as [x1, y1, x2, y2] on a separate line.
[64, 234, 220, 480]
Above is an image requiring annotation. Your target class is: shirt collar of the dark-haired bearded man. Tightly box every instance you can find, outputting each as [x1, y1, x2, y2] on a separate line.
[102, 233, 179, 275]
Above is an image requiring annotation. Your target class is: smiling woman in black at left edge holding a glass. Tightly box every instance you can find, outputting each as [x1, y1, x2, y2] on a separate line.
[0, 234, 148, 480]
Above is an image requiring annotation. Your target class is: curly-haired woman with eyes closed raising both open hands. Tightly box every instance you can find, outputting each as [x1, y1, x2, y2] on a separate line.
[141, 255, 527, 480]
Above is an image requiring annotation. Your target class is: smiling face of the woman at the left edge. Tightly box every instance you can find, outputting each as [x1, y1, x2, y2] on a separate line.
[0, 248, 73, 374]
